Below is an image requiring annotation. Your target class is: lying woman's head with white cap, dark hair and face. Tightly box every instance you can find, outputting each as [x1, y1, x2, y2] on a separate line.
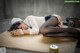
[8, 18, 28, 31]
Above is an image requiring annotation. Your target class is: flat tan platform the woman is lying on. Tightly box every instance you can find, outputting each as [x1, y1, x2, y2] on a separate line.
[0, 31, 77, 53]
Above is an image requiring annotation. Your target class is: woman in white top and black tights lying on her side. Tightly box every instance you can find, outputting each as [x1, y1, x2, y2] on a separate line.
[9, 14, 80, 36]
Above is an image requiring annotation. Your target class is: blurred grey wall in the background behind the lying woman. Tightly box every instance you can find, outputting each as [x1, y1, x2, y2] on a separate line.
[0, 0, 80, 19]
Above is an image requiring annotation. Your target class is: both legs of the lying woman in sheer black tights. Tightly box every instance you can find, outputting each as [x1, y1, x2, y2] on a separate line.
[40, 17, 80, 34]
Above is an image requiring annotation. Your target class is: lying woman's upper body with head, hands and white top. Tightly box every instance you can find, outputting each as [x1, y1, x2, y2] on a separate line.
[9, 15, 44, 35]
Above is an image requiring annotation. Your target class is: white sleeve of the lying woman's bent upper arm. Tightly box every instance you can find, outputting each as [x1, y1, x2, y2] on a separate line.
[24, 16, 39, 34]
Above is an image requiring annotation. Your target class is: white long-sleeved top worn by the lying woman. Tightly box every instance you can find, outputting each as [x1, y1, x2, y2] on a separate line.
[24, 15, 45, 34]
